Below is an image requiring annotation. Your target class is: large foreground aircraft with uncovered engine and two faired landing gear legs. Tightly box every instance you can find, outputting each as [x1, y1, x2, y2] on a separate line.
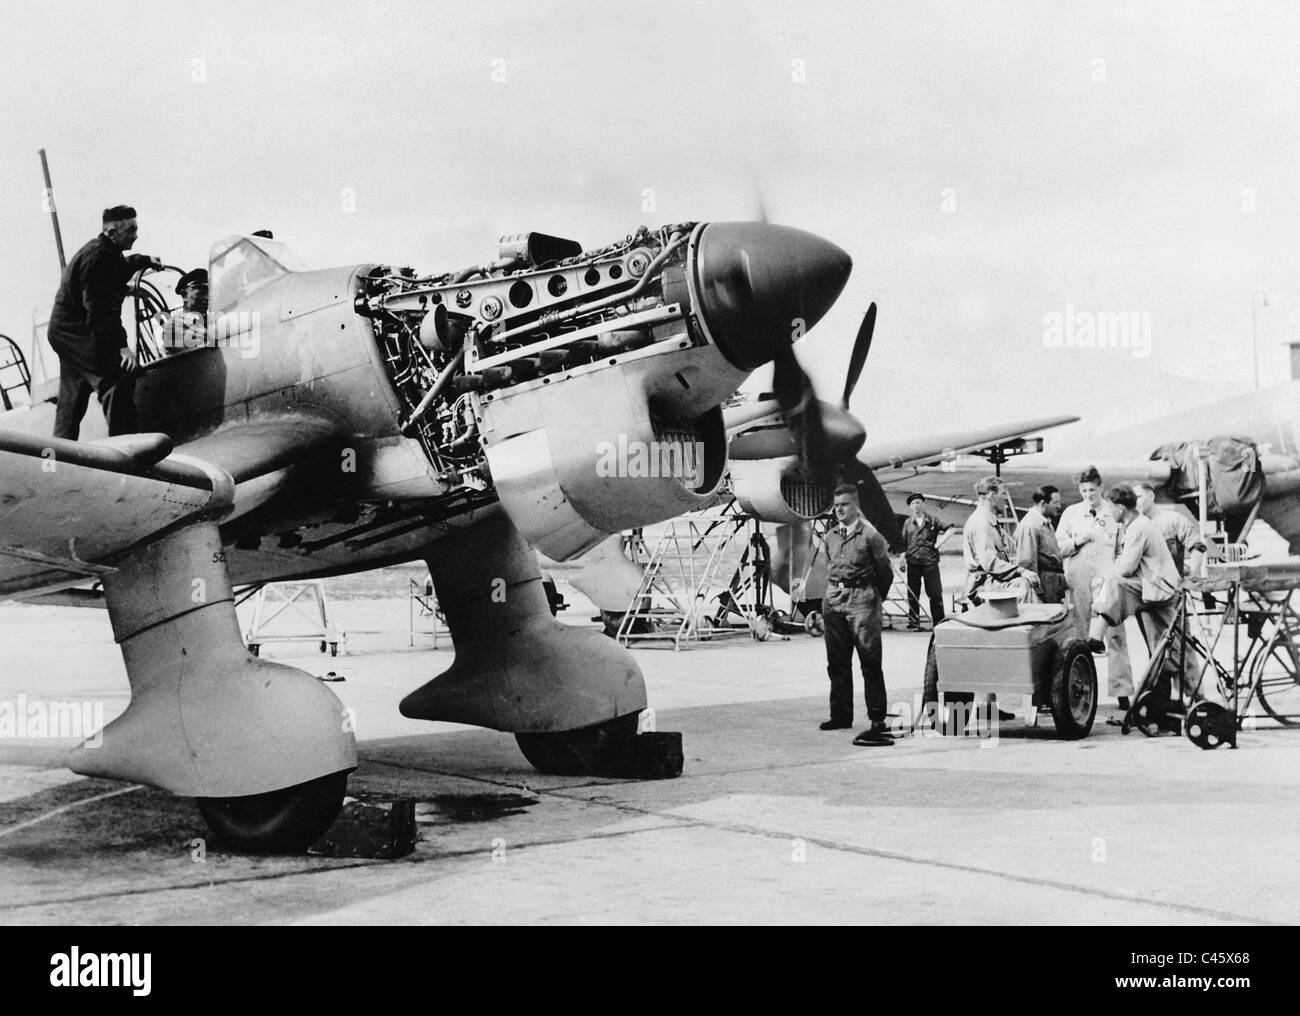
[0, 222, 850, 850]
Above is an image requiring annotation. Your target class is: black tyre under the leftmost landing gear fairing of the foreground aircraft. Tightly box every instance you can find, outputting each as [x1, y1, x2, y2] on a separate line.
[195, 772, 347, 854]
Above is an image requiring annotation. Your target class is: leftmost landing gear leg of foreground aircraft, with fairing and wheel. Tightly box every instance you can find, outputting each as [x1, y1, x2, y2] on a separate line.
[69, 521, 356, 852]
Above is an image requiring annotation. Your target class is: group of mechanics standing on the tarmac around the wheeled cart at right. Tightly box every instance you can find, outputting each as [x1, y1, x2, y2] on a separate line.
[820, 466, 1205, 744]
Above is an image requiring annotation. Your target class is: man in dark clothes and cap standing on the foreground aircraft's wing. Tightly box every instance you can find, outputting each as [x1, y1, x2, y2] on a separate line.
[48, 205, 163, 440]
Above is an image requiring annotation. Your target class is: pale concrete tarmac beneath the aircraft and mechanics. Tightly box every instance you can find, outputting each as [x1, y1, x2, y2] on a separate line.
[0, 591, 1300, 925]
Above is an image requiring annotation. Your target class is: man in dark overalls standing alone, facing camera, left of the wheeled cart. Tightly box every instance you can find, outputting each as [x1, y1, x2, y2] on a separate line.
[822, 483, 893, 735]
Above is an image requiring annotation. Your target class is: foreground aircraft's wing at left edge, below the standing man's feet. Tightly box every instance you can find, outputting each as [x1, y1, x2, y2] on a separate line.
[0, 431, 234, 598]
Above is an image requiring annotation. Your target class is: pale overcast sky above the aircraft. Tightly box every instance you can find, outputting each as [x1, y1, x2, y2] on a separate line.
[0, 0, 1300, 446]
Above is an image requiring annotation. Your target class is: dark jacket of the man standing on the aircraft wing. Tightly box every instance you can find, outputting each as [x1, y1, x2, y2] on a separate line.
[49, 233, 150, 374]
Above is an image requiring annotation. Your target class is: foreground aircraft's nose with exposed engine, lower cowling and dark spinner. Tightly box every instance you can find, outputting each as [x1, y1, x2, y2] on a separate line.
[358, 222, 849, 560]
